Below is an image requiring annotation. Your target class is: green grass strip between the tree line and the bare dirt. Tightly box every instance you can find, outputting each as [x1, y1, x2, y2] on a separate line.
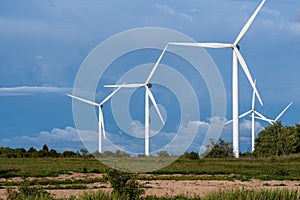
[0, 155, 300, 181]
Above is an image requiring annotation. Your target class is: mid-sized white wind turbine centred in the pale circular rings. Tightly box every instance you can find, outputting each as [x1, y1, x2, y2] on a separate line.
[104, 45, 168, 156]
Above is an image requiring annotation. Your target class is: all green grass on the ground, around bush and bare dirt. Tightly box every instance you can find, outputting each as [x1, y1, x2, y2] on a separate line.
[0, 154, 300, 200]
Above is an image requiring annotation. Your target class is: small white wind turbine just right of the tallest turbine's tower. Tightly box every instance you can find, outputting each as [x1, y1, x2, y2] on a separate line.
[225, 80, 268, 152]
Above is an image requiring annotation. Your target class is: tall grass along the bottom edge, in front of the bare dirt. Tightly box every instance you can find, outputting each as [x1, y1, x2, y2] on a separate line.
[8, 189, 300, 200]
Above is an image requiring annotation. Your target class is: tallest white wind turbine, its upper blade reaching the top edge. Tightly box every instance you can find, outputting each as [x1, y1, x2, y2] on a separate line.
[169, 0, 266, 158]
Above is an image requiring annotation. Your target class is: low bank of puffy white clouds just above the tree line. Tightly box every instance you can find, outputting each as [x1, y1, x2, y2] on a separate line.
[0, 117, 264, 155]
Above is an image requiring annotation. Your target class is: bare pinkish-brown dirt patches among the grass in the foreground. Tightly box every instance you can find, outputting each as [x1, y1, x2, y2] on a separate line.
[0, 173, 300, 199]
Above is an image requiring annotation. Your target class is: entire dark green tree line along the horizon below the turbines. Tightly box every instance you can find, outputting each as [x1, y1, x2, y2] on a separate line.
[0, 122, 300, 160]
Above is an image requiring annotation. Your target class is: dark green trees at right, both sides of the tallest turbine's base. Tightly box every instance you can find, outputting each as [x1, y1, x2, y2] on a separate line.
[204, 122, 300, 158]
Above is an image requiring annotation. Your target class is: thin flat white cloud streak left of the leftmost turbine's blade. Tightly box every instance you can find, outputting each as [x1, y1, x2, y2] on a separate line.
[0, 86, 72, 96]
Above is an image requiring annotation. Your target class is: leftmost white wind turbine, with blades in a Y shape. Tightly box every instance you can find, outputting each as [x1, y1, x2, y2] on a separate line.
[68, 83, 125, 153]
